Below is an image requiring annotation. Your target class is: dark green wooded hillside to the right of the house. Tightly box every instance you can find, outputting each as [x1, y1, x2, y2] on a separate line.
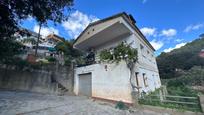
[157, 34, 204, 79]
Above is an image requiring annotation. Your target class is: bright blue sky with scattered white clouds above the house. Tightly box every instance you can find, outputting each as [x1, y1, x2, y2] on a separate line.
[22, 0, 204, 54]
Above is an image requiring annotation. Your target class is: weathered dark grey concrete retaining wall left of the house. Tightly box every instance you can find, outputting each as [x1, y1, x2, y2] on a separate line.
[0, 66, 73, 94]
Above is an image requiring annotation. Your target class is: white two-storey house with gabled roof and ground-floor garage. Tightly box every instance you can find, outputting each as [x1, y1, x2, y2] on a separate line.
[74, 12, 161, 104]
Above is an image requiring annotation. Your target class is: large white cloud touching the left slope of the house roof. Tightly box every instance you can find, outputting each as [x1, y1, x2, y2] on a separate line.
[62, 10, 99, 39]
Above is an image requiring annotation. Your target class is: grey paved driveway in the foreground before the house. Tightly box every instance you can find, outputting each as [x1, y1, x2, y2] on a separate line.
[0, 91, 166, 115]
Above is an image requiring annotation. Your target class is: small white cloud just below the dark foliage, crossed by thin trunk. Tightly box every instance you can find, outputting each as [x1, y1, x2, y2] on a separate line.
[33, 25, 59, 37]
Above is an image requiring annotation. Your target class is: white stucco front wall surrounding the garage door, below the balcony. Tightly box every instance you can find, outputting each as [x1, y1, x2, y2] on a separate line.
[74, 62, 132, 103]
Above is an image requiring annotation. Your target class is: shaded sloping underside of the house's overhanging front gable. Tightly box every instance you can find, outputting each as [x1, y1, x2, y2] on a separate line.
[74, 22, 132, 51]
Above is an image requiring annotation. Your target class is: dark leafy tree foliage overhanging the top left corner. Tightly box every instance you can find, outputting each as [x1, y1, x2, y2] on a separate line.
[0, 0, 73, 61]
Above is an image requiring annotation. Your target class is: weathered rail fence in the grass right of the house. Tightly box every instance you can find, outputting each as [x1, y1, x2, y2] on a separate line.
[139, 94, 201, 112]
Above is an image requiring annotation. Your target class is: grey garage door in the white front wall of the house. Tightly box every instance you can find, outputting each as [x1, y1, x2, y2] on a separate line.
[79, 73, 92, 97]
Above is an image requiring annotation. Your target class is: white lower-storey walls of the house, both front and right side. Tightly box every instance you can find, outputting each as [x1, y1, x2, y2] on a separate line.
[74, 62, 161, 103]
